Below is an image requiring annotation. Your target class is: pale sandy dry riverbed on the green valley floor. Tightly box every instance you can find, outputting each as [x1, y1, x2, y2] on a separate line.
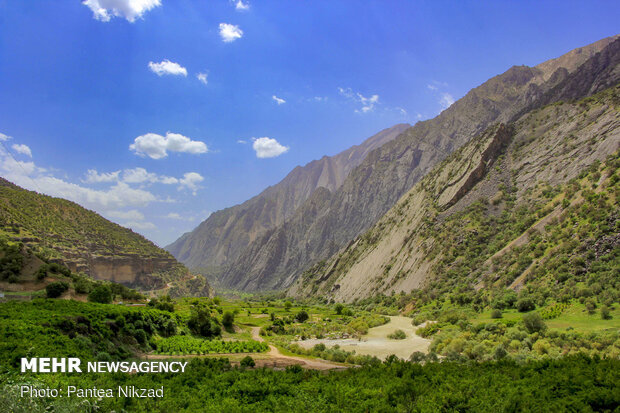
[296, 316, 431, 360]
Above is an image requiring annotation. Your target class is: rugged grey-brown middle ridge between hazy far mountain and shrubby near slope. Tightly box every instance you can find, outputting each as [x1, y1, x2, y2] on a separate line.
[222, 36, 620, 290]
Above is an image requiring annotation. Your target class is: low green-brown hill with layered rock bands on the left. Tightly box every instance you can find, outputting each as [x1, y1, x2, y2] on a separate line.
[0, 178, 210, 295]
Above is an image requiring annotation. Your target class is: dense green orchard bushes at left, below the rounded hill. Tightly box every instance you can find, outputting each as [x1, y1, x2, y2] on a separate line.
[0, 299, 177, 366]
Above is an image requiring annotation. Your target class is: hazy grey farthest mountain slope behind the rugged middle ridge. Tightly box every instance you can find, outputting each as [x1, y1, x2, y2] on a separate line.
[166, 124, 410, 269]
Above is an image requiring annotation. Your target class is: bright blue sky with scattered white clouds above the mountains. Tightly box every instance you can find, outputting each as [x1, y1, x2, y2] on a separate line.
[0, 0, 620, 246]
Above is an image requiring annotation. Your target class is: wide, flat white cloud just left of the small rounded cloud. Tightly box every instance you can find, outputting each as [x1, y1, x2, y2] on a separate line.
[129, 132, 209, 159]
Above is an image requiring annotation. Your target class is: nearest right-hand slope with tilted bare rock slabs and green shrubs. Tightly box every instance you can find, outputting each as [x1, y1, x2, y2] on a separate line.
[289, 82, 620, 301]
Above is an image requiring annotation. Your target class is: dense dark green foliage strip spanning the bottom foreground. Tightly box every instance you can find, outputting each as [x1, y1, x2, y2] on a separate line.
[0, 356, 620, 412]
